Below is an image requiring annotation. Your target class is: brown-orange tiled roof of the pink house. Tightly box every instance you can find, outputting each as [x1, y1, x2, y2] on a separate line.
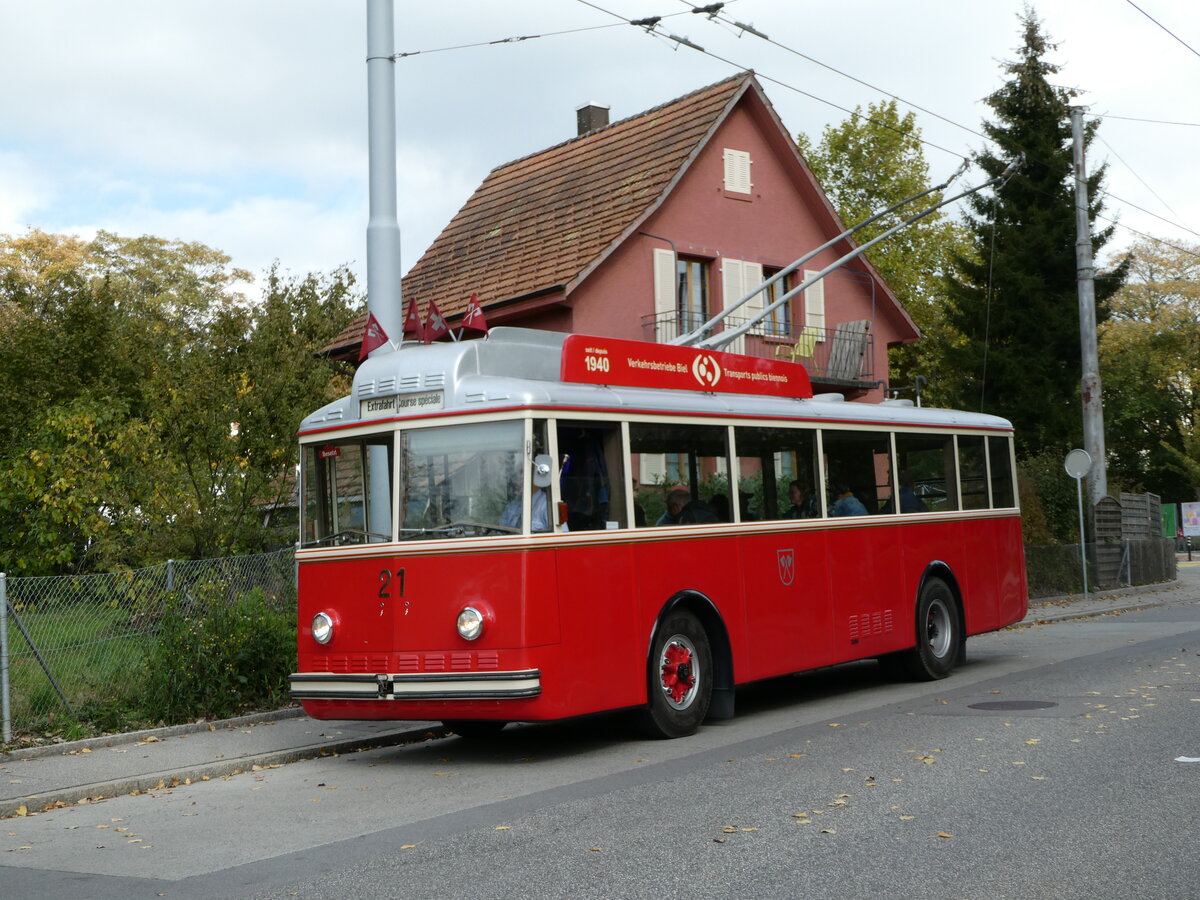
[331, 72, 754, 348]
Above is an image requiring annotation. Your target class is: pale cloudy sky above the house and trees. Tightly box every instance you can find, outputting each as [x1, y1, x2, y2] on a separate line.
[0, 0, 1200, 292]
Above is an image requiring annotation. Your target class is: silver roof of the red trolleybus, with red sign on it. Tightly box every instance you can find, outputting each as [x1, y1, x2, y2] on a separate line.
[300, 328, 1012, 436]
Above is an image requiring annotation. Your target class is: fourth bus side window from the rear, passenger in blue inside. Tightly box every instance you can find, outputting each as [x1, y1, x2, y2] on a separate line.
[821, 428, 893, 516]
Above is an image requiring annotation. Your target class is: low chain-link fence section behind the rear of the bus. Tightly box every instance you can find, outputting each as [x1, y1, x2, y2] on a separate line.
[1025, 538, 1176, 598]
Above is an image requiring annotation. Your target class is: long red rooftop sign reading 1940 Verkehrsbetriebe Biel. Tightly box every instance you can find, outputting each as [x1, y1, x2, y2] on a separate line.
[560, 335, 812, 398]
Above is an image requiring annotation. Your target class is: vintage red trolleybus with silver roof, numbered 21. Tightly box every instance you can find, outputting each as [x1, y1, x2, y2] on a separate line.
[290, 328, 1027, 737]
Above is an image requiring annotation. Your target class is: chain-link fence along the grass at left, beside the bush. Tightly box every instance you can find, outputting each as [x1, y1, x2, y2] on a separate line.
[0, 550, 295, 742]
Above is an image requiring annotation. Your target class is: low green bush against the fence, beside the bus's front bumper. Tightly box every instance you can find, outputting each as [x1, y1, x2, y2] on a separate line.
[140, 588, 296, 725]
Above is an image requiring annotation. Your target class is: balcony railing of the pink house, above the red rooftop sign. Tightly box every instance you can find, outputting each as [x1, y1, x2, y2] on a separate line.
[642, 311, 875, 388]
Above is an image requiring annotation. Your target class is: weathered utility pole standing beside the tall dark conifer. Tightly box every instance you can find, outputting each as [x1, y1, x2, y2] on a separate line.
[1070, 107, 1109, 520]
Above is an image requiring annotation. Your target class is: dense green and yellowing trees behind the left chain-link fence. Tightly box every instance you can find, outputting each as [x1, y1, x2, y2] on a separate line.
[0, 230, 360, 574]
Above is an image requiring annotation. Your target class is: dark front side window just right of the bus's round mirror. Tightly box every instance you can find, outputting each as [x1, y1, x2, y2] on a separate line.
[558, 421, 632, 532]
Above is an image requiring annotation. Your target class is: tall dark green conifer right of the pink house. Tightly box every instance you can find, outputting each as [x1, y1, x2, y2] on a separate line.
[946, 7, 1124, 455]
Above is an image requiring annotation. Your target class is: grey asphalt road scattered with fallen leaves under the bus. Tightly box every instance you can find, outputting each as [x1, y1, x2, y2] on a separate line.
[0, 592, 1200, 900]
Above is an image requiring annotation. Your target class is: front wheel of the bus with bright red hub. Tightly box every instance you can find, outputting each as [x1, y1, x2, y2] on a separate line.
[641, 610, 713, 738]
